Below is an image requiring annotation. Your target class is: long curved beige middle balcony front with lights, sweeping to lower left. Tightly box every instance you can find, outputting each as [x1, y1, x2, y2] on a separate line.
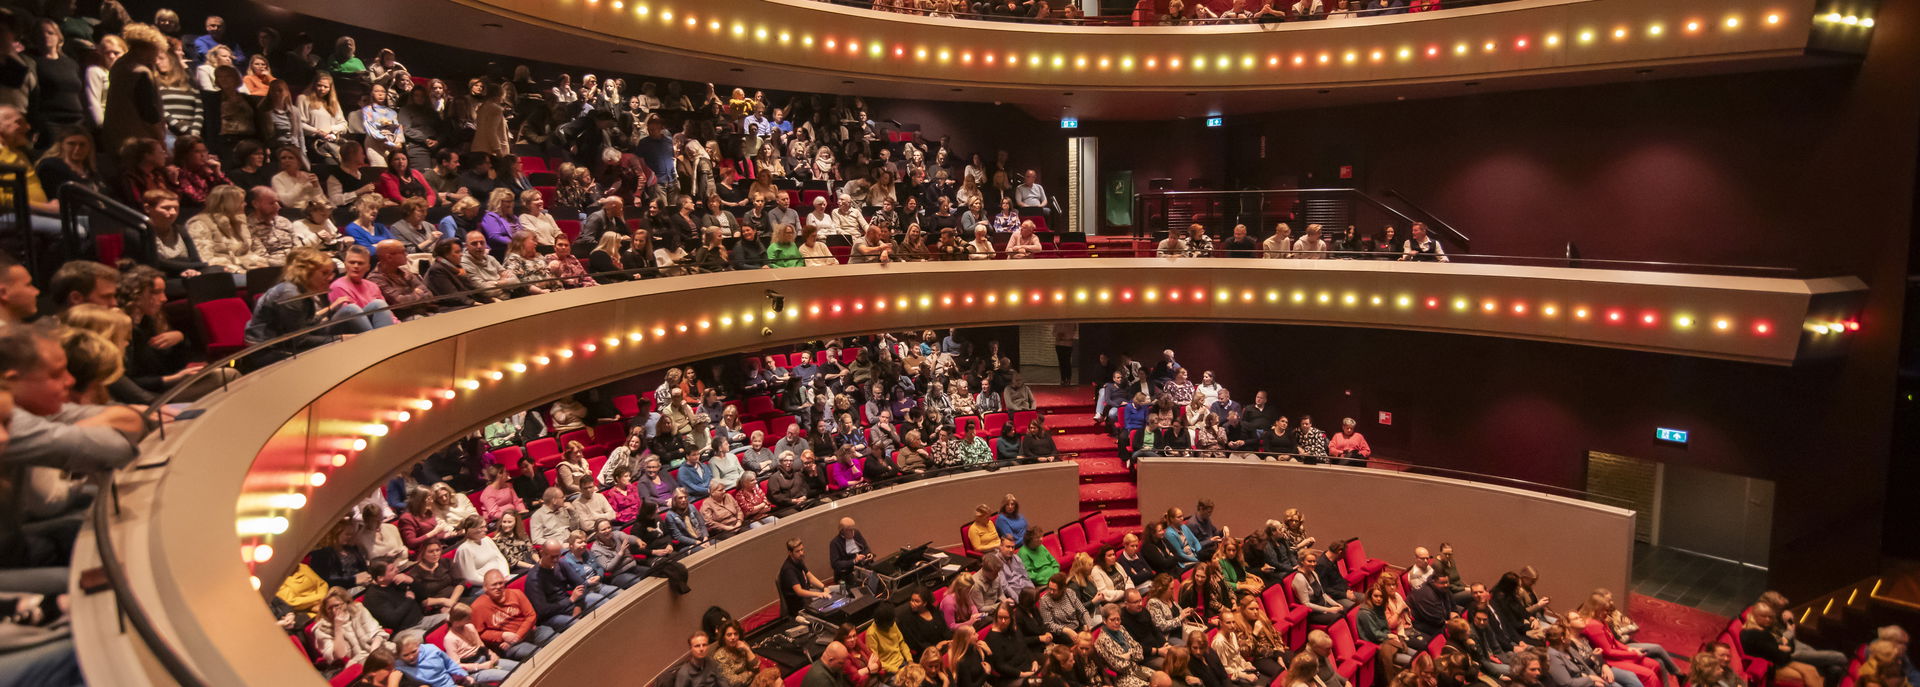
[73, 259, 1862, 685]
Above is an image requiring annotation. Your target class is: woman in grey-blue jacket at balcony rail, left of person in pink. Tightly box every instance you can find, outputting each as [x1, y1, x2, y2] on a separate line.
[246, 248, 394, 365]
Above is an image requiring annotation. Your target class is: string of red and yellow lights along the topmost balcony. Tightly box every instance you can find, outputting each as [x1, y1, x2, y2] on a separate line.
[537, 0, 1874, 73]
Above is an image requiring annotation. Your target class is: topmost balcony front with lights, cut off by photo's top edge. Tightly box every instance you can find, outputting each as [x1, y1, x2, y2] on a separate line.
[270, 0, 1874, 119]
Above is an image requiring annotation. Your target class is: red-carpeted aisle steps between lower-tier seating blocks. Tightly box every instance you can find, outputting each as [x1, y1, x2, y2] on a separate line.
[1033, 386, 1140, 530]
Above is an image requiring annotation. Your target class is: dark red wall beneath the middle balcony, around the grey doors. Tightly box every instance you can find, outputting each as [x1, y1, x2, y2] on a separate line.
[1081, 322, 1885, 597]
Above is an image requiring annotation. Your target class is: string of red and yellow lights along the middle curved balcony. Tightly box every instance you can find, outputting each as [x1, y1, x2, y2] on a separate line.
[224, 278, 1860, 589]
